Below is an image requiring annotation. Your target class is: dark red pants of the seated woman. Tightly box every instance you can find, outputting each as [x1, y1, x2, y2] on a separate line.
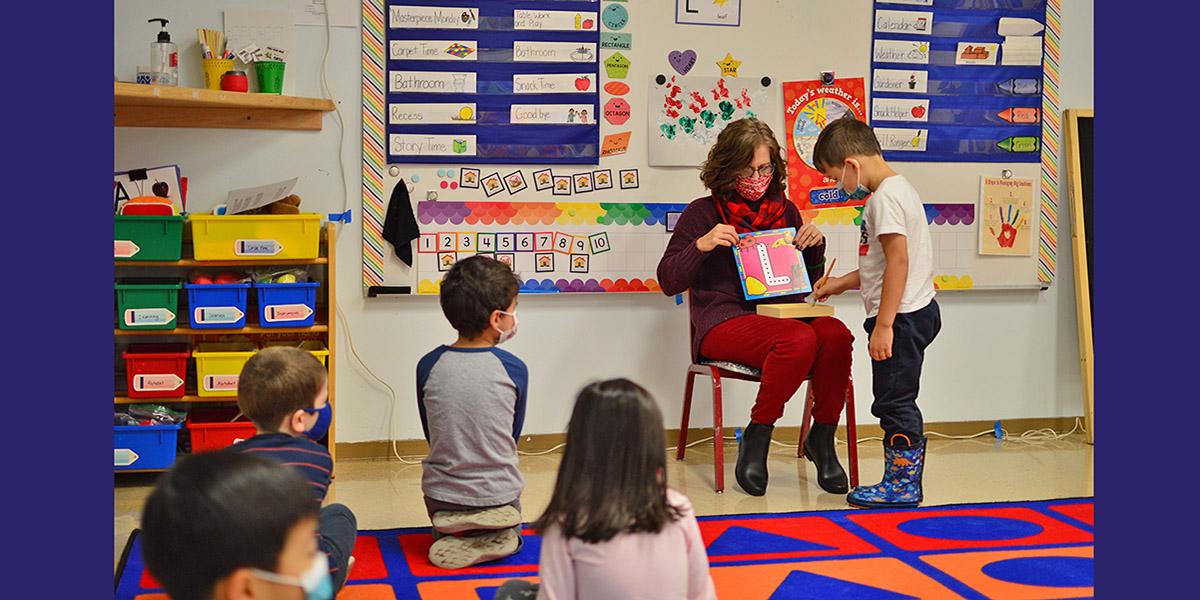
[700, 314, 854, 425]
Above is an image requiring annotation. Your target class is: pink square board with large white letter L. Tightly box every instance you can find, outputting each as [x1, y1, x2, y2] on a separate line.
[733, 227, 812, 300]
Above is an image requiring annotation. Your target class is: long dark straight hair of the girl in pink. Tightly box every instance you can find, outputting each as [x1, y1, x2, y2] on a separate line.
[534, 379, 680, 544]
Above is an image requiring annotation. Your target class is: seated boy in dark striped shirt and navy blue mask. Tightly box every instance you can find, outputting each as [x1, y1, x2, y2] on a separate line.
[229, 347, 358, 592]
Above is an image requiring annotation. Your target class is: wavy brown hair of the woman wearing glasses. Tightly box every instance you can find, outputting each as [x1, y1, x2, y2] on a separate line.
[700, 116, 787, 194]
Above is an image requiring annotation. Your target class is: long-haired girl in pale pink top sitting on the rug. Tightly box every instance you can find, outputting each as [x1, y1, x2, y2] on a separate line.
[496, 379, 716, 600]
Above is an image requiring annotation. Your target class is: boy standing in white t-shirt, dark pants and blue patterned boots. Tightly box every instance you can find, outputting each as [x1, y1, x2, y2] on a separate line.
[812, 118, 942, 508]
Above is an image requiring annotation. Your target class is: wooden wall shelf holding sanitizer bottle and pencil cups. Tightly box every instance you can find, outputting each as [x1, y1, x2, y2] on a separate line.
[113, 82, 334, 131]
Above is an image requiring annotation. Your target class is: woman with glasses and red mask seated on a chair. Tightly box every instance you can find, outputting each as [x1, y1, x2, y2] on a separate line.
[658, 119, 854, 496]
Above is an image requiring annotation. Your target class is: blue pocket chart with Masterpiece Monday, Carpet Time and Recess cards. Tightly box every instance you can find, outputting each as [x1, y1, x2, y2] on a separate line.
[384, 0, 601, 164]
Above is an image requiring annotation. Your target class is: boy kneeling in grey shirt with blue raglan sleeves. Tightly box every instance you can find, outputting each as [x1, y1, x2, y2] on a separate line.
[416, 257, 529, 569]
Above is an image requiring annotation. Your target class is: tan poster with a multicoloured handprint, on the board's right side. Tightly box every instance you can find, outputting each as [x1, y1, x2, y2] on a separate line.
[978, 176, 1036, 257]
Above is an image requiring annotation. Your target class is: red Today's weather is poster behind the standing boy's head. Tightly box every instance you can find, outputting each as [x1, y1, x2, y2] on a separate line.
[782, 77, 866, 210]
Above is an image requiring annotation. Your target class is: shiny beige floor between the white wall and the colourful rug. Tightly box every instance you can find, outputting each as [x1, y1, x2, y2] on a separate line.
[113, 434, 1093, 570]
